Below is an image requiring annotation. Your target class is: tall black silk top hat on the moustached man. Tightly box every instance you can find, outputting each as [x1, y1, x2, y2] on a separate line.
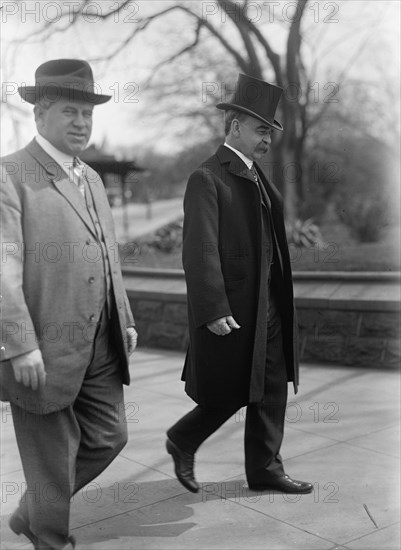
[216, 74, 283, 130]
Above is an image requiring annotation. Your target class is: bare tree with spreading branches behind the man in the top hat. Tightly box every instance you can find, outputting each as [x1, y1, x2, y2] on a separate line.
[5, 0, 394, 221]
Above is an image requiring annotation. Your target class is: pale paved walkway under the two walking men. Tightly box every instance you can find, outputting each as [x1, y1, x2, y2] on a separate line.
[1, 349, 400, 550]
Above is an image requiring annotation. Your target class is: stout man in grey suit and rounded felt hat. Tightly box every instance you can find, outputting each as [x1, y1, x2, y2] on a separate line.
[0, 59, 136, 550]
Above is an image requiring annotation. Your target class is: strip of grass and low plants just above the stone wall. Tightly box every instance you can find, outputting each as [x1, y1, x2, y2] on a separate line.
[121, 220, 401, 272]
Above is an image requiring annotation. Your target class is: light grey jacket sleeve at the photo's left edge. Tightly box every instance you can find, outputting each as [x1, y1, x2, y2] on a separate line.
[0, 166, 39, 361]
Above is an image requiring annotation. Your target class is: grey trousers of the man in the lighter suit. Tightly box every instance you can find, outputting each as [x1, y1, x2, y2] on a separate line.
[11, 312, 127, 550]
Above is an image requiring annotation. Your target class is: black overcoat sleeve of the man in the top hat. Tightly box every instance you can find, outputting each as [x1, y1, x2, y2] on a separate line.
[182, 168, 232, 327]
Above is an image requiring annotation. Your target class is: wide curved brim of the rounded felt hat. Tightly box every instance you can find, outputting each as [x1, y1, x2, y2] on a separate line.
[18, 85, 111, 105]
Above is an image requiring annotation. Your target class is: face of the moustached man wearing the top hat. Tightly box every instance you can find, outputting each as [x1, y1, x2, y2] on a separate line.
[233, 116, 273, 160]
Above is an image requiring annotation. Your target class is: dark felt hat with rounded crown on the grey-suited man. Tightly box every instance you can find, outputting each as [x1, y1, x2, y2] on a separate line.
[18, 59, 111, 105]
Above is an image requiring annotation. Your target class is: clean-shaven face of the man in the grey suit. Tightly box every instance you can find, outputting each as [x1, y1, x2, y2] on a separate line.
[36, 99, 93, 156]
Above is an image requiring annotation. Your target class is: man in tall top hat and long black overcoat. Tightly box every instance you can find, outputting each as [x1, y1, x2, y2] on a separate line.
[166, 74, 312, 493]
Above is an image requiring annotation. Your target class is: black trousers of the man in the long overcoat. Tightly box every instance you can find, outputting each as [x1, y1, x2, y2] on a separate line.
[167, 302, 288, 482]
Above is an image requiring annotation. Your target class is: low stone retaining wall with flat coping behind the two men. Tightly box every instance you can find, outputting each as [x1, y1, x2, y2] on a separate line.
[124, 270, 400, 368]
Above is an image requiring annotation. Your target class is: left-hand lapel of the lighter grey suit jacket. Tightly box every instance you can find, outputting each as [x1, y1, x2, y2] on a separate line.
[27, 140, 96, 236]
